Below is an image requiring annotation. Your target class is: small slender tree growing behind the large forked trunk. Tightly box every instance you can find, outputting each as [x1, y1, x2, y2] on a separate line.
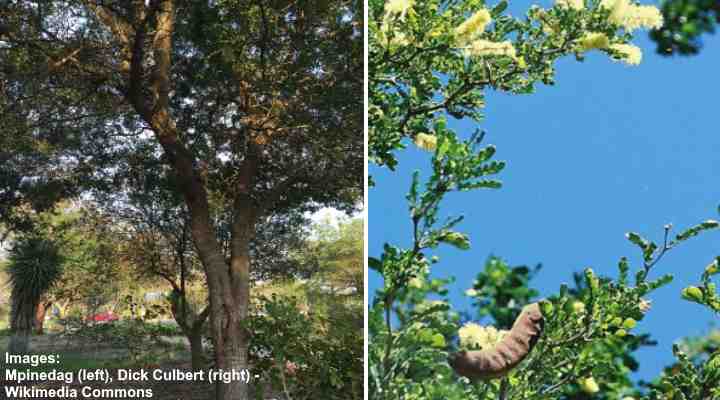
[96, 155, 307, 369]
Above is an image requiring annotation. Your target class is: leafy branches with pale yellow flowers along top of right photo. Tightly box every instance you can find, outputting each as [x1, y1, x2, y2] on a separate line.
[368, 0, 656, 176]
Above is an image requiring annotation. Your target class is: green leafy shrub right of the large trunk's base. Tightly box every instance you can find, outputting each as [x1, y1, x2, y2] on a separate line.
[247, 295, 363, 399]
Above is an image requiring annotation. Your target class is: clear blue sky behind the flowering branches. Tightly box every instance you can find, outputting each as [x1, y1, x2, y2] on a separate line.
[368, 1, 720, 379]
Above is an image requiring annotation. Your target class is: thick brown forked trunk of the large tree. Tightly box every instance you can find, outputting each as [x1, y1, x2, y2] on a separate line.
[91, 0, 257, 400]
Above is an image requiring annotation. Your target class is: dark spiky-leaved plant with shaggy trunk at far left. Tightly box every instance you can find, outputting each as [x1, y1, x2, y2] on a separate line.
[7, 236, 62, 354]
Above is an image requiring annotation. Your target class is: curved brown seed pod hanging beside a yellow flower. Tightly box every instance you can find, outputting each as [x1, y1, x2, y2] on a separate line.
[448, 303, 545, 379]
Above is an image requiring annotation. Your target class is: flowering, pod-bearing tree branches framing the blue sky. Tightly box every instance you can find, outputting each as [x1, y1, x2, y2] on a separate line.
[368, 0, 720, 400]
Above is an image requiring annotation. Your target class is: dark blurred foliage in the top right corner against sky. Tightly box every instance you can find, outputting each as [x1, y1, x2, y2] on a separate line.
[650, 0, 720, 55]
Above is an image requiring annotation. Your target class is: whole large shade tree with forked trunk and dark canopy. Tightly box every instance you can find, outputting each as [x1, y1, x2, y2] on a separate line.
[0, 0, 363, 399]
